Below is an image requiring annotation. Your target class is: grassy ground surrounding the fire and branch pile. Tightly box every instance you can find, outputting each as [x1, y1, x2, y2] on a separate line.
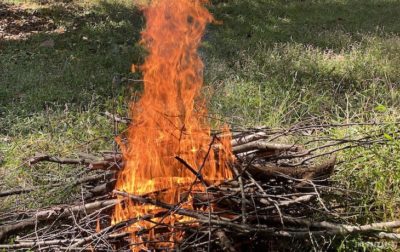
[0, 0, 400, 250]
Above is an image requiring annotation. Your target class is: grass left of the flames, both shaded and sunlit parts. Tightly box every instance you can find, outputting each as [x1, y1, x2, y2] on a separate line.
[0, 1, 143, 208]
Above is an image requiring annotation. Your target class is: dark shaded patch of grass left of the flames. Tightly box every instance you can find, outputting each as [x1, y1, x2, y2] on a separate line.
[0, 1, 143, 113]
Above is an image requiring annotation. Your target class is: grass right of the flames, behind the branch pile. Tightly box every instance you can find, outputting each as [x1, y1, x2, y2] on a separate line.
[206, 0, 400, 125]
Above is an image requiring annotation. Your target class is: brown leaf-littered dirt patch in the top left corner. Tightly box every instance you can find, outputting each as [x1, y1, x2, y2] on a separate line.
[0, 3, 57, 40]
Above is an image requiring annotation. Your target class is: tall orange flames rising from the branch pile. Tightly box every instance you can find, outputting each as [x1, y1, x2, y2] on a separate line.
[113, 0, 232, 251]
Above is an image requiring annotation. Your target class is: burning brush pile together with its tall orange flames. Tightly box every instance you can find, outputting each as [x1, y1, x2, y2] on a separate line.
[0, 0, 400, 251]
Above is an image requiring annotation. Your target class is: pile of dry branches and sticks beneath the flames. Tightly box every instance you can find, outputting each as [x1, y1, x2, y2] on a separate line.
[0, 121, 400, 251]
